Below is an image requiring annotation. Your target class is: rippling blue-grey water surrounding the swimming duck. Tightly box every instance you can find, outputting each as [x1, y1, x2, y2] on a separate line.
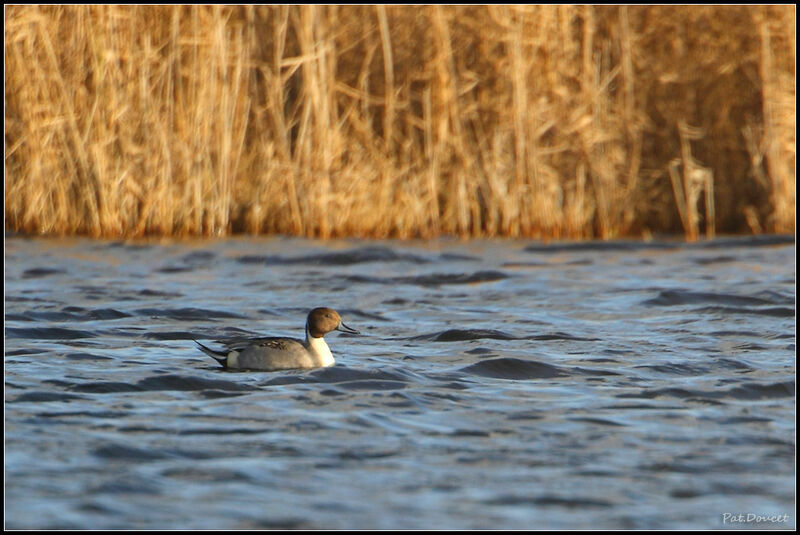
[5, 236, 795, 529]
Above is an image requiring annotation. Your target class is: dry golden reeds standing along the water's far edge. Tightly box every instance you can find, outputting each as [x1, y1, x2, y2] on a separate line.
[4, 5, 795, 239]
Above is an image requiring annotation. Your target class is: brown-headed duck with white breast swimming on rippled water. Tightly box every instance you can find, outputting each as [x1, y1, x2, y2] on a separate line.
[195, 308, 359, 371]
